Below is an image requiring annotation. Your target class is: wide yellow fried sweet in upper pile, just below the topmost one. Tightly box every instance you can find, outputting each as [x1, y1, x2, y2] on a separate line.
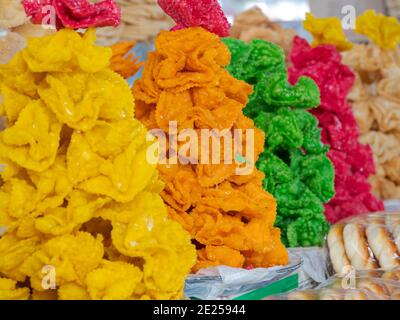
[38, 70, 134, 131]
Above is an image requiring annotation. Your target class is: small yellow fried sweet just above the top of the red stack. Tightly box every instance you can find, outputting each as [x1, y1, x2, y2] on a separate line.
[304, 13, 353, 51]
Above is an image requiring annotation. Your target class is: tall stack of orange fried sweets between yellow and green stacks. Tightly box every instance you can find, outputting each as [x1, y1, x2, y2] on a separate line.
[133, 27, 288, 271]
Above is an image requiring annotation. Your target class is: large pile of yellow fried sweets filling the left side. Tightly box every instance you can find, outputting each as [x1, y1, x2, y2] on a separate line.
[0, 29, 196, 299]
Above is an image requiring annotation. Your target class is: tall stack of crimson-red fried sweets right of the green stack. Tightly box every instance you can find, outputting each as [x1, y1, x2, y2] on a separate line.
[290, 38, 383, 224]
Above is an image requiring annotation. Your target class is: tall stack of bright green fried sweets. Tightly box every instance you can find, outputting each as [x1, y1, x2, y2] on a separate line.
[224, 38, 334, 247]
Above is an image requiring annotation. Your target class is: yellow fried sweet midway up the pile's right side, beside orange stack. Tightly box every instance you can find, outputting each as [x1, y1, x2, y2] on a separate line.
[67, 119, 155, 202]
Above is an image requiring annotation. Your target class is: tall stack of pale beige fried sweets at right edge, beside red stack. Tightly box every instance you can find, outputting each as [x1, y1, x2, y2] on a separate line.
[344, 49, 400, 199]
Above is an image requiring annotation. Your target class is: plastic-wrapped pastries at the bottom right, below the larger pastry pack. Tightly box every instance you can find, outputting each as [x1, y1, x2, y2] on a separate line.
[267, 269, 400, 300]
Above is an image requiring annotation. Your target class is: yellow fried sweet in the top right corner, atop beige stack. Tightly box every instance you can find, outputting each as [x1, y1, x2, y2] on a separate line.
[356, 10, 400, 50]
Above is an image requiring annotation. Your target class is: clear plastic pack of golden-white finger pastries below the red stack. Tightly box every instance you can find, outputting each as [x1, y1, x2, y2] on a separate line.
[327, 212, 400, 274]
